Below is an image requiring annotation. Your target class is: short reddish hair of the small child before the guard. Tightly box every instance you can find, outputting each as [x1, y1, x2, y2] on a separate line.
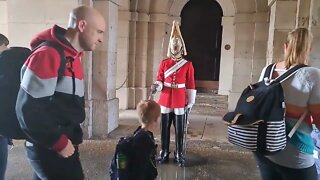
[137, 100, 160, 124]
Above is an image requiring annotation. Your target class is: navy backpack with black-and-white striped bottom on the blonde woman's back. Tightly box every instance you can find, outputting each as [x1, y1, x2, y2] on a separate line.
[223, 64, 306, 155]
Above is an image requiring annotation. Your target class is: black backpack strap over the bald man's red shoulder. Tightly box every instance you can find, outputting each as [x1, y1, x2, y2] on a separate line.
[32, 41, 67, 79]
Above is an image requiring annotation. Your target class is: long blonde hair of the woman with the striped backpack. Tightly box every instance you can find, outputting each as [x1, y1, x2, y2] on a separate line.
[284, 28, 312, 69]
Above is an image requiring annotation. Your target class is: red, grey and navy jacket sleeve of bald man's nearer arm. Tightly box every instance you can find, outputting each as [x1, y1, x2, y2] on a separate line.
[16, 47, 68, 151]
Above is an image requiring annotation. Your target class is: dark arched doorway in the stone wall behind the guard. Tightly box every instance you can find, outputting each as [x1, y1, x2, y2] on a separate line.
[181, 0, 223, 92]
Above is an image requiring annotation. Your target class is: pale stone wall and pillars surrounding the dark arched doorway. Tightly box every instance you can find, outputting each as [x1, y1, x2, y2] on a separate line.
[0, 0, 320, 137]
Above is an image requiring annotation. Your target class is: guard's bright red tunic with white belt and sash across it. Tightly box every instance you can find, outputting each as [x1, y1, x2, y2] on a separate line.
[157, 58, 195, 108]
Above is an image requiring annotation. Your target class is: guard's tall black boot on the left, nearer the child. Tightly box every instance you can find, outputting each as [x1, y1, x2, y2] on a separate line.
[158, 113, 172, 164]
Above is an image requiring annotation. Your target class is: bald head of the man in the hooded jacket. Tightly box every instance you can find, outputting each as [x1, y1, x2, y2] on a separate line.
[66, 6, 106, 51]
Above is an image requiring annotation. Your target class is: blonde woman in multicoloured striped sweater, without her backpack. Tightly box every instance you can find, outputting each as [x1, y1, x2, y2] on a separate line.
[254, 28, 320, 180]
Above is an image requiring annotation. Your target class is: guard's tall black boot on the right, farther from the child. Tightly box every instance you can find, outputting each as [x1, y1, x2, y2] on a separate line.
[174, 115, 186, 167]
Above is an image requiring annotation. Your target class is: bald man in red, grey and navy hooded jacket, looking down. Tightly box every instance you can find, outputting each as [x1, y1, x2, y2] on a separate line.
[16, 6, 106, 180]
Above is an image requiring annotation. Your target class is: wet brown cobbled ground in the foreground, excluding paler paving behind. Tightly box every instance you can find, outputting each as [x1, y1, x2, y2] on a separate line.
[7, 139, 259, 180]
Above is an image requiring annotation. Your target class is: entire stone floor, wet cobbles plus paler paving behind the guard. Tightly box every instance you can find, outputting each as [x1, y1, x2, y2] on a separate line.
[7, 111, 260, 180]
